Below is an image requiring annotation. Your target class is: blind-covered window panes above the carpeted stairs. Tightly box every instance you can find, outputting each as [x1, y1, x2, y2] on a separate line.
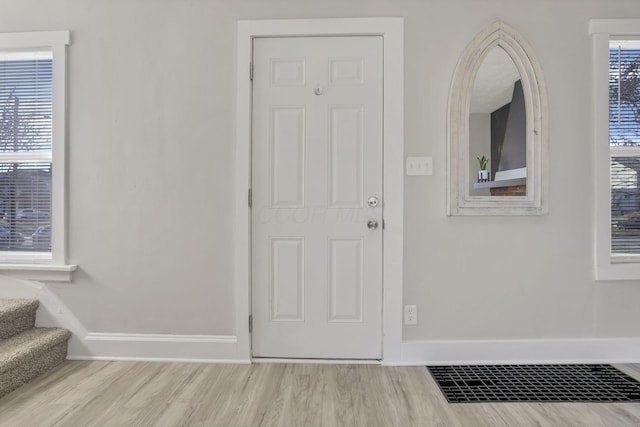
[0, 50, 53, 252]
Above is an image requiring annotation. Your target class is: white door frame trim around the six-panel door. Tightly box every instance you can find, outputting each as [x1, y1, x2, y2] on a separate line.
[233, 18, 404, 364]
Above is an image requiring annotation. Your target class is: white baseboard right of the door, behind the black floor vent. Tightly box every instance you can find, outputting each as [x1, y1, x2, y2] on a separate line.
[392, 338, 640, 366]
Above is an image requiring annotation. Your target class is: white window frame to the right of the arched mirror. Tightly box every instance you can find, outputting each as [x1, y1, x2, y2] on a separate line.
[589, 19, 640, 280]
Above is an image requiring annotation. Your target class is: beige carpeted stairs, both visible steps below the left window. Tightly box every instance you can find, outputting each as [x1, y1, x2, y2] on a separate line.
[0, 298, 71, 397]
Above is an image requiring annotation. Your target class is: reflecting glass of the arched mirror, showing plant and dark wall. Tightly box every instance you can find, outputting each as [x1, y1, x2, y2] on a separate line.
[468, 46, 527, 197]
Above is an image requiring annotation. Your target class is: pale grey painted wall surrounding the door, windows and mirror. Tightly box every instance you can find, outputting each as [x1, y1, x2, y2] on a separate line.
[0, 0, 640, 362]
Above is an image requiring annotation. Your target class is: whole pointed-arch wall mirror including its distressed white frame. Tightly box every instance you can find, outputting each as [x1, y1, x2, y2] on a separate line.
[448, 22, 547, 215]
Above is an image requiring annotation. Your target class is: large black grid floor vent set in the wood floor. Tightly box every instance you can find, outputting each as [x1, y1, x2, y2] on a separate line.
[427, 365, 640, 403]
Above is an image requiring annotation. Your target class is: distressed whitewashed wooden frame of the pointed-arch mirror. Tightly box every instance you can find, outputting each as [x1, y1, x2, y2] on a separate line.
[447, 21, 548, 215]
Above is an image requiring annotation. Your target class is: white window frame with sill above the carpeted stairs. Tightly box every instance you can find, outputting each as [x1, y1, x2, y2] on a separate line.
[0, 31, 77, 282]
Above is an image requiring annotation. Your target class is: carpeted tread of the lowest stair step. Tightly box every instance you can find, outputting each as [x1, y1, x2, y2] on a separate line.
[0, 328, 71, 373]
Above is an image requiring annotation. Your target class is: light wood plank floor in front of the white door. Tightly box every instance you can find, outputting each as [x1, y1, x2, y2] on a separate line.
[0, 362, 640, 427]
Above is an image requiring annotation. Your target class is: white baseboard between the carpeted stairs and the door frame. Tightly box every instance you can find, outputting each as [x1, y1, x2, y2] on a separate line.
[68, 332, 249, 363]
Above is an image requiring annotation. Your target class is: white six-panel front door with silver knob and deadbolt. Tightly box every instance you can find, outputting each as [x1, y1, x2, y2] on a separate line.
[251, 36, 383, 359]
